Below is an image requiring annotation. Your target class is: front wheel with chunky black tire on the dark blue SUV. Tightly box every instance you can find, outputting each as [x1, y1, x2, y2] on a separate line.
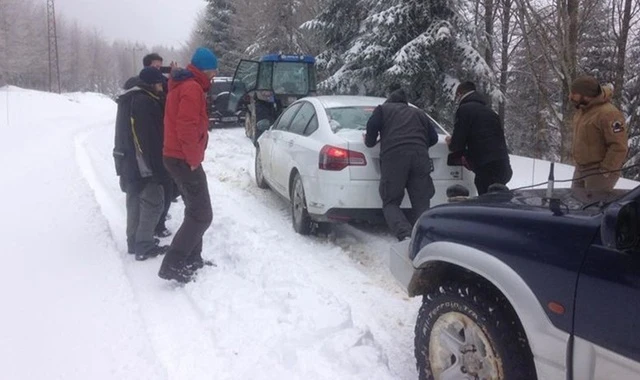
[415, 282, 536, 380]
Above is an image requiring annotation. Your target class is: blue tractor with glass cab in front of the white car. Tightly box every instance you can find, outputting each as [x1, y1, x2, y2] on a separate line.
[228, 54, 316, 143]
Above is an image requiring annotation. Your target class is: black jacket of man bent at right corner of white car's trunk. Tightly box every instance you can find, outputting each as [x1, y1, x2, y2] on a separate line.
[449, 91, 509, 169]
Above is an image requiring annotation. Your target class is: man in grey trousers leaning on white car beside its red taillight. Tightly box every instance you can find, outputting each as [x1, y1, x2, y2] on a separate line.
[364, 86, 438, 241]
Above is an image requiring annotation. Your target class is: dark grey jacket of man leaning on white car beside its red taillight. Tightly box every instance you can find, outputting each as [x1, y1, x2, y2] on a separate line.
[365, 89, 438, 156]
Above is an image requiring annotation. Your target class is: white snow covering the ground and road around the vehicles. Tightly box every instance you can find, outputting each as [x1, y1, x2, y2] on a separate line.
[0, 87, 635, 380]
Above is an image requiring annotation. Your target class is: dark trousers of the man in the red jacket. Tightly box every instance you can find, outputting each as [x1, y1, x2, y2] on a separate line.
[163, 157, 213, 269]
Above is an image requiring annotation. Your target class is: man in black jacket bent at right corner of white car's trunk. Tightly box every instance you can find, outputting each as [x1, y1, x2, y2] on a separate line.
[446, 82, 513, 195]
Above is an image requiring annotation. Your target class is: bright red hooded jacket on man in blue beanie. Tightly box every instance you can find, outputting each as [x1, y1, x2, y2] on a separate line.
[163, 65, 211, 167]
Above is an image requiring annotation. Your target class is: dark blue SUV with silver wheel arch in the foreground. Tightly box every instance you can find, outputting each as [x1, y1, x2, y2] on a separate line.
[390, 187, 640, 380]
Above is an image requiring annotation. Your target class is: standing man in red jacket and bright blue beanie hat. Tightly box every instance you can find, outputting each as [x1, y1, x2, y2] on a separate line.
[158, 47, 218, 283]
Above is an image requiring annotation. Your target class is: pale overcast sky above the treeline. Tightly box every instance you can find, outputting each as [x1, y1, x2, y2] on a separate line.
[55, 0, 205, 48]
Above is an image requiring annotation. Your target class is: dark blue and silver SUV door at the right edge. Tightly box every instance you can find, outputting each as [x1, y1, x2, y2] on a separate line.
[567, 206, 640, 380]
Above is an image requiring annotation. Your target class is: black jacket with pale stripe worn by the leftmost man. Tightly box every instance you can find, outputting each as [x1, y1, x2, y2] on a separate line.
[113, 79, 167, 182]
